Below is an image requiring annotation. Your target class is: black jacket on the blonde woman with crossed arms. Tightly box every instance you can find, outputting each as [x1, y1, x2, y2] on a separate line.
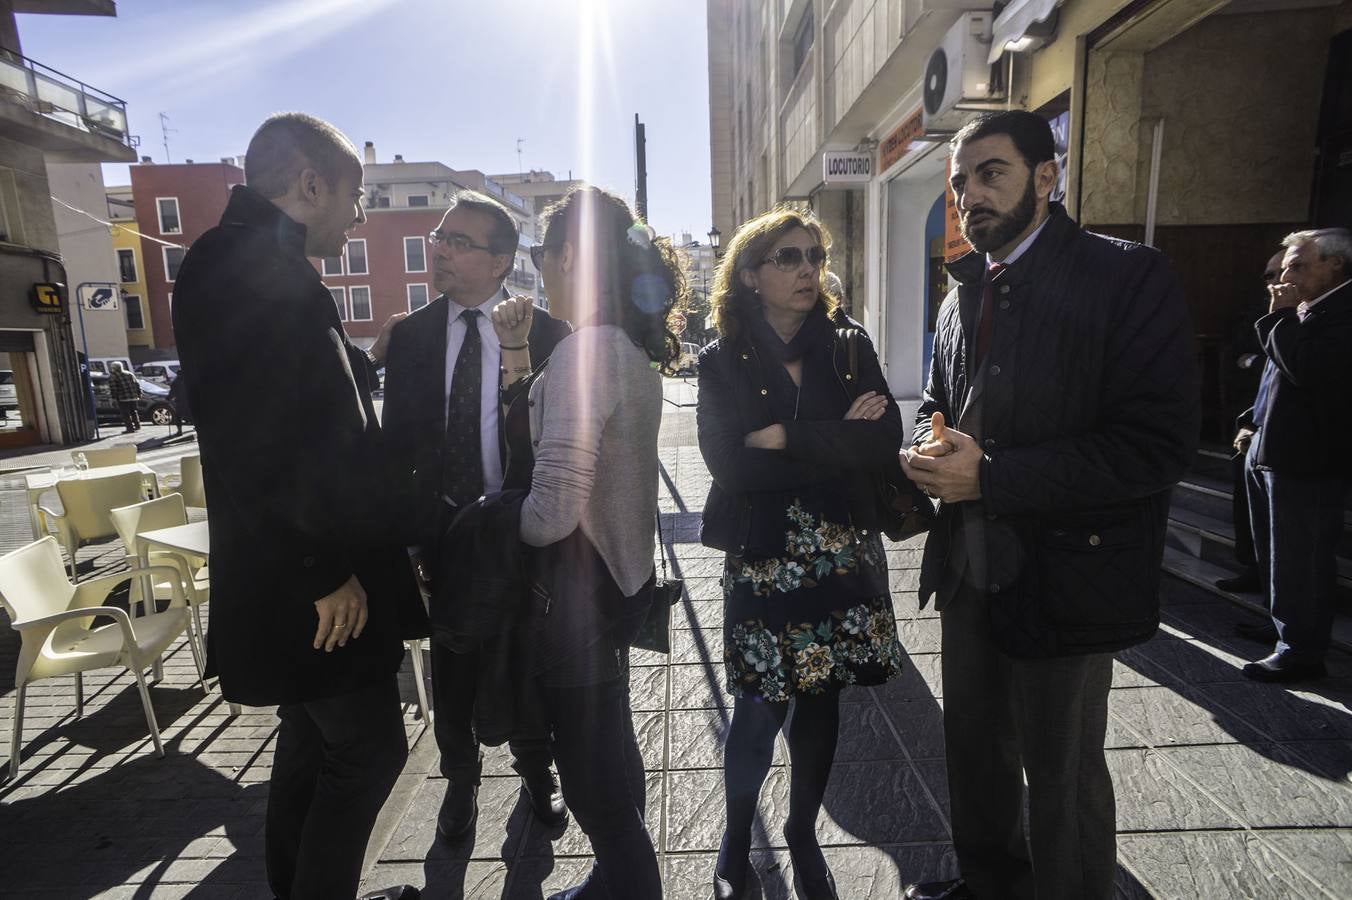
[698, 314, 904, 555]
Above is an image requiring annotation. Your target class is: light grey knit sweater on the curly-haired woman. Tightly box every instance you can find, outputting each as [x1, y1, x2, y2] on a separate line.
[521, 326, 662, 596]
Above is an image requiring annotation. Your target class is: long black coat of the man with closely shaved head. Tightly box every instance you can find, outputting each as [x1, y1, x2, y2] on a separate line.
[173, 186, 427, 705]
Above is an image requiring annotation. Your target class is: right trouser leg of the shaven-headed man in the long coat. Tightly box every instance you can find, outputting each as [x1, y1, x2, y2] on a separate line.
[291, 674, 408, 900]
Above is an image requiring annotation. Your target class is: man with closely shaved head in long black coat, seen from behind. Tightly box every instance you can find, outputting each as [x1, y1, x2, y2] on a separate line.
[173, 114, 427, 900]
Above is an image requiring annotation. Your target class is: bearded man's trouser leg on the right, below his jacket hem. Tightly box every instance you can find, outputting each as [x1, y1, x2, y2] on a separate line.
[1013, 653, 1117, 900]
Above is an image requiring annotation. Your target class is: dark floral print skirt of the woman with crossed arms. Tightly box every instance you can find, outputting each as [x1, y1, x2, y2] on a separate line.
[723, 504, 903, 703]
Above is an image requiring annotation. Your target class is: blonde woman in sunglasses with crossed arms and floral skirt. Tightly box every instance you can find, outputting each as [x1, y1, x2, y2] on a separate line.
[698, 208, 903, 900]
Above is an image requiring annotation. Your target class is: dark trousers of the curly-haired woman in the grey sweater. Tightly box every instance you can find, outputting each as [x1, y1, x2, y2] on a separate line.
[545, 678, 662, 900]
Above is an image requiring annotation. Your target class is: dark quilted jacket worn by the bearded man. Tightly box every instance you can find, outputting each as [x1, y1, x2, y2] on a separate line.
[913, 204, 1201, 658]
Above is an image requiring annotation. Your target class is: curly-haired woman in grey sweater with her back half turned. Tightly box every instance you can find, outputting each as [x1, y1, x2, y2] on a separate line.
[492, 188, 685, 900]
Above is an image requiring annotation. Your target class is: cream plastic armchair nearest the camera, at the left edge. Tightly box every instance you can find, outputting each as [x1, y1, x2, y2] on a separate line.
[0, 535, 201, 778]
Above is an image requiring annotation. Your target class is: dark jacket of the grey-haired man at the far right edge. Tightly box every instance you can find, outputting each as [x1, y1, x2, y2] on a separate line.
[1240, 284, 1352, 478]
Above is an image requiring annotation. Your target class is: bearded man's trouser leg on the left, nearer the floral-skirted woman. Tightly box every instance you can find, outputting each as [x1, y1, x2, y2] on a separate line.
[940, 586, 1033, 899]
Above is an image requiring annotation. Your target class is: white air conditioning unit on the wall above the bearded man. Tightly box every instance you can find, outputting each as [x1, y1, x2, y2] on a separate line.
[923, 12, 1005, 135]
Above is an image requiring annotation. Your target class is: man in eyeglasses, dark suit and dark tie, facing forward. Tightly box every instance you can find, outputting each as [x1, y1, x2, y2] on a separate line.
[384, 191, 569, 839]
